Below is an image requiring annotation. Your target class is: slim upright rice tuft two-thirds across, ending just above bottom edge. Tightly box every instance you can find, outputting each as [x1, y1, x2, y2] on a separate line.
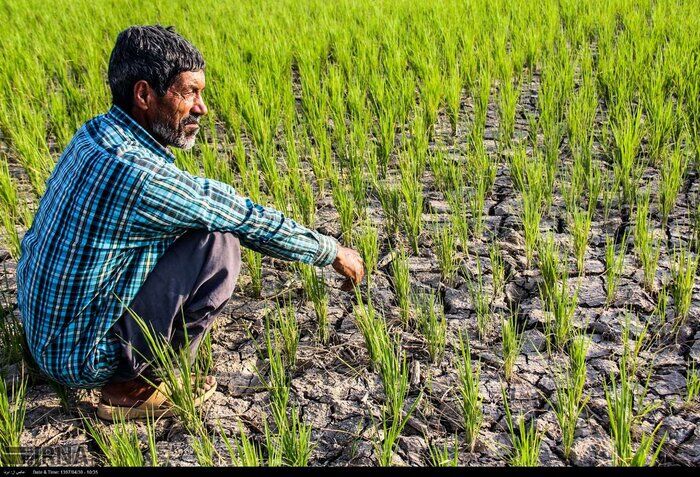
[457, 331, 484, 451]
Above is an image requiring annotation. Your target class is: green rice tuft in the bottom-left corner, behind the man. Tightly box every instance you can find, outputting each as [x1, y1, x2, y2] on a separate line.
[0, 375, 27, 467]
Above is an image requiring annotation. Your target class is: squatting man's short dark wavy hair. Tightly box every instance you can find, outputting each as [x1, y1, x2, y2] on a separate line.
[107, 25, 204, 111]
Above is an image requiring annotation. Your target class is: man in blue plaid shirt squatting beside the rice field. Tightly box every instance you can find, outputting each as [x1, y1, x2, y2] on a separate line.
[17, 26, 364, 418]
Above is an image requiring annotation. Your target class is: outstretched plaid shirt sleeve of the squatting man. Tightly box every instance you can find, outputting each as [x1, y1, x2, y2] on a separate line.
[131, 159, 338, 266]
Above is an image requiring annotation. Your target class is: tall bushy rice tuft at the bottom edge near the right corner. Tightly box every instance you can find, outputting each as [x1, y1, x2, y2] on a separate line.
[604, 315, 666, 466]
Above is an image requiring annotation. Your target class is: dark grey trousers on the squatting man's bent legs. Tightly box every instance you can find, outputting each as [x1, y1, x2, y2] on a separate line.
[110, 230, 241, 382]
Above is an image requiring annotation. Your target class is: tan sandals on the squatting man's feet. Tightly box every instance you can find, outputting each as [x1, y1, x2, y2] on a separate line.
[97, 374, 217, 421]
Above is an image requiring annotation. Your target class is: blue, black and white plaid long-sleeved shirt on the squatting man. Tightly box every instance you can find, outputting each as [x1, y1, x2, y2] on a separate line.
[17, 106, 337, 388]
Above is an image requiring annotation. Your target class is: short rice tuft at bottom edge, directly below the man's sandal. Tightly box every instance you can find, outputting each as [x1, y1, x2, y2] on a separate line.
[83, 413, 159, 467]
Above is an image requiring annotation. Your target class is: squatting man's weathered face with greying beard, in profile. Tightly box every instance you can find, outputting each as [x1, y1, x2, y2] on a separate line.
[149, 70, 207, 149]
